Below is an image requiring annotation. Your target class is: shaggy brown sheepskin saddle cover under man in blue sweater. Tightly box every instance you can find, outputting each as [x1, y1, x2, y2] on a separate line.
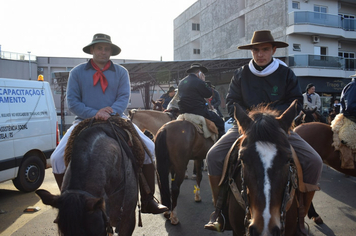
[64, 116, 147, 167]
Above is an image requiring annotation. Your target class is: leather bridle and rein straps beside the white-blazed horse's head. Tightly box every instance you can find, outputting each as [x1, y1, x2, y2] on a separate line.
[229, 159, 298, 236]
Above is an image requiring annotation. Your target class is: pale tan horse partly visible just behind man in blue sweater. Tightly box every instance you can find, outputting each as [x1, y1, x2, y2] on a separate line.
[129, 109, 176, 135]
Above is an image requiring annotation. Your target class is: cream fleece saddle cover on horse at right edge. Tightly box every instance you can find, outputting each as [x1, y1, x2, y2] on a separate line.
[331, 113, 356, 169]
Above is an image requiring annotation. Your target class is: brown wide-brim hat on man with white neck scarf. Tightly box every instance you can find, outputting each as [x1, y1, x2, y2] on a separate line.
[237, 30, 289, 49]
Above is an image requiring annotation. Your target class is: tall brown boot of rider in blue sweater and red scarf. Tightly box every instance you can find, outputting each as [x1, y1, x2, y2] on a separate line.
[140, 163, 169, 214]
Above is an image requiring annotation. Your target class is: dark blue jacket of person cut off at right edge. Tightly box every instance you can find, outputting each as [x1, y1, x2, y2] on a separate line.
[340, 79, 356, 120]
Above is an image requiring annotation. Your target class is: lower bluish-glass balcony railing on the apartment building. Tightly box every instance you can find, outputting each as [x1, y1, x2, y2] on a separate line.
[289, 55, 356, 71]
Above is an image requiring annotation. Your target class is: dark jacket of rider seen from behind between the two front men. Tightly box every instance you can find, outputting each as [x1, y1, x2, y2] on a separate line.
[178, 74, 212, 118]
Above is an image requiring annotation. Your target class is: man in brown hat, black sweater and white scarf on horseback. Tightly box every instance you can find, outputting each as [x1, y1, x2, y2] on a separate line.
[205, 30, 322, 230]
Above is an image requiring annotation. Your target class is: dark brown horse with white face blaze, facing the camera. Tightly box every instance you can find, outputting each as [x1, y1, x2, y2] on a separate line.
[223, 101, 314, 236]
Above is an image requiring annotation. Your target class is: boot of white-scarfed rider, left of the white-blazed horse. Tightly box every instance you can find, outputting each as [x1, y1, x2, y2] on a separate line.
[204, 175, 226, 232]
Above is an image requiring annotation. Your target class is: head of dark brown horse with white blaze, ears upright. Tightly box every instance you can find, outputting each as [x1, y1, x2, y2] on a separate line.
[235, 100, 297, 235]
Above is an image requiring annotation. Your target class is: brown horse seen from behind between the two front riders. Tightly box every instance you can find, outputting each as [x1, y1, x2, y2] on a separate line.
[155, 120, 214, 225]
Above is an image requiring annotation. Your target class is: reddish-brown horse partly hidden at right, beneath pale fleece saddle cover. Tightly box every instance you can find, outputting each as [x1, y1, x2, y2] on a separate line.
[294, 122, 356, 177]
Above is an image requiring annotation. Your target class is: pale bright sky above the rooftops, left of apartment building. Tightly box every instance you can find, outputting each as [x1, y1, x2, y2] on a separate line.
[0, 0, 197, 61]
